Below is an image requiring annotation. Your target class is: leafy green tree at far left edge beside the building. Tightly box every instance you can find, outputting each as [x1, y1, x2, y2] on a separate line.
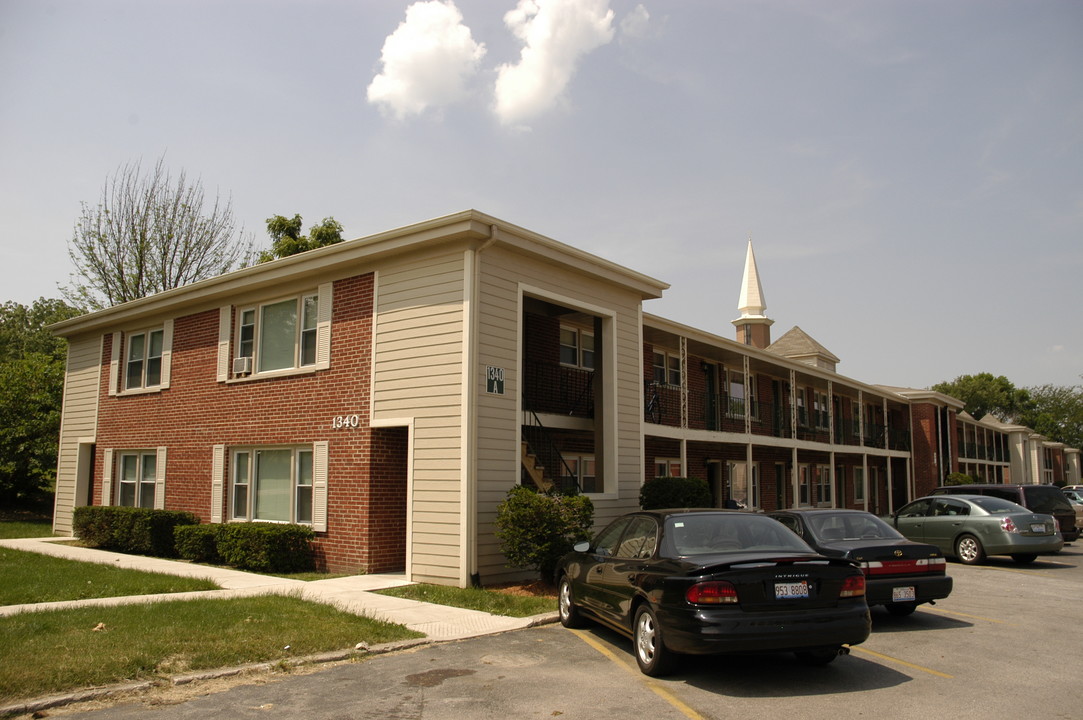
[0, 298, 82, 508]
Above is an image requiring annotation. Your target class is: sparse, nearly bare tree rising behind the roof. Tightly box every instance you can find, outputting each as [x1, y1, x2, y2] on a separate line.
[64, 156, 251, 310]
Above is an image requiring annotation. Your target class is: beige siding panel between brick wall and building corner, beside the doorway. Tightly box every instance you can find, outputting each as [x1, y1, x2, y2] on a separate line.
[371, 251, 465, 585]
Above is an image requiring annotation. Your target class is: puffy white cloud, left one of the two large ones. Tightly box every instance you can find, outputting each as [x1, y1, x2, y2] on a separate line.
[368, 0, 485, 118]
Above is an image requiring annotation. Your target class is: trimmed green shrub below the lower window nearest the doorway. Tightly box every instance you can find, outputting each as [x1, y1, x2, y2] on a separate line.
[216, 523, 315, 573]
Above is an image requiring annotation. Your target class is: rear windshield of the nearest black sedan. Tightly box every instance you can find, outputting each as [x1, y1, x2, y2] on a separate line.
[665, 512, 813, 558]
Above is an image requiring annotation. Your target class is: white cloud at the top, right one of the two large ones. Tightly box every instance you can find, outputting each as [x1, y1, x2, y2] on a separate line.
[496, 0, 613, 125]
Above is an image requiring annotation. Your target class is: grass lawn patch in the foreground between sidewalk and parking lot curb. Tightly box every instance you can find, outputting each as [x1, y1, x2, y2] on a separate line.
[0, 595, 421, 702]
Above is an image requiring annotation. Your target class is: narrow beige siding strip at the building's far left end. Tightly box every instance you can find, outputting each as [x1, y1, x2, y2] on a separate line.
[53, 336, 102, 535]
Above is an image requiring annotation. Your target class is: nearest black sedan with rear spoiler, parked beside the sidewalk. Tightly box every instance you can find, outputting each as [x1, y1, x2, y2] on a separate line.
[556, 510, 871, 676]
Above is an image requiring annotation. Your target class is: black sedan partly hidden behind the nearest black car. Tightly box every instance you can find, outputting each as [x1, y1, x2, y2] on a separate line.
[768, 509, 952, 615]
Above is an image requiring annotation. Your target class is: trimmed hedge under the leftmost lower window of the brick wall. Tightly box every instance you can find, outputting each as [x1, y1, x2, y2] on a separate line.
[73, 506, 199, 558]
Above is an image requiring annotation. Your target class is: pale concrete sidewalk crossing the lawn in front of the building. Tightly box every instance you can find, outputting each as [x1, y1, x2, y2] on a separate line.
[0, 537, 557, 641]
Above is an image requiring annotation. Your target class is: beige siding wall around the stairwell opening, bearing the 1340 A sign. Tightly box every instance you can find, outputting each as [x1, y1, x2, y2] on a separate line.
[477, 247, 642, 582]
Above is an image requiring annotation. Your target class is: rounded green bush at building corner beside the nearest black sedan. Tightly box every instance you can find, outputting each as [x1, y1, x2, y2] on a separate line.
[496, 485, 595, 579]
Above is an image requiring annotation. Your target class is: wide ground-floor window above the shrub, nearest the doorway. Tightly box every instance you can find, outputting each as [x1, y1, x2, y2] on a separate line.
[230, 447, 314, 524]
